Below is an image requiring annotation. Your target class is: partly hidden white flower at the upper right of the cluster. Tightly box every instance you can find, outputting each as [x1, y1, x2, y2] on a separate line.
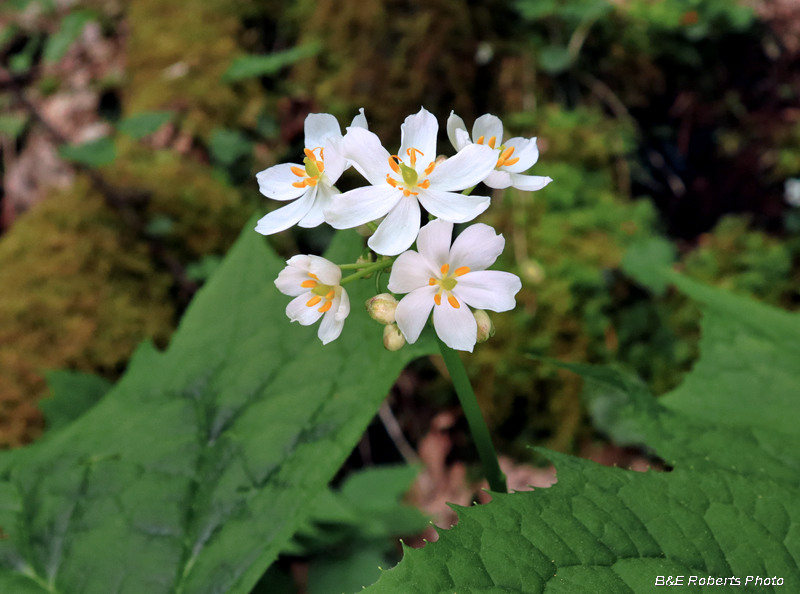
[447, 112, 553, 192]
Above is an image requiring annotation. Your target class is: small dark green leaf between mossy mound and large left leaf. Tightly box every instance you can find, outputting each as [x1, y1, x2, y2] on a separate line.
[39, 371, 111, 430]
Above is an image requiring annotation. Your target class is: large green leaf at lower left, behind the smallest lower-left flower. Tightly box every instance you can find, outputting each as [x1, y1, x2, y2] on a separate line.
[0, 221, 433, 594]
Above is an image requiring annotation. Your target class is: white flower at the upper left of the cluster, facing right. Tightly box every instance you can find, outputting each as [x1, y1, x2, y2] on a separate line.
[256, 109, 367, 235]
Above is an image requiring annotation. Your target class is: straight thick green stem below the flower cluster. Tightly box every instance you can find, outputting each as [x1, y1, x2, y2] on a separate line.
[436, 336, 508, 493]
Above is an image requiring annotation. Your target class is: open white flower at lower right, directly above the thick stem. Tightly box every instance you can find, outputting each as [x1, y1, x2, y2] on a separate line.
[389, 220, 522, 352]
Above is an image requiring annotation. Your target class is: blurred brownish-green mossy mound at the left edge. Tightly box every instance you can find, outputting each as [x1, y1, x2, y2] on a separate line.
[0, 180, 174, 447]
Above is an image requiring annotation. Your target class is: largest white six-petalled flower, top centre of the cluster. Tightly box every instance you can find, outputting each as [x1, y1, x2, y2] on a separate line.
[325, 108, 496, 256]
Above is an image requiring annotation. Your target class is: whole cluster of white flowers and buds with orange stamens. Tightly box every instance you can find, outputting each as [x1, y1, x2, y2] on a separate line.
[256, 108, 551, 351]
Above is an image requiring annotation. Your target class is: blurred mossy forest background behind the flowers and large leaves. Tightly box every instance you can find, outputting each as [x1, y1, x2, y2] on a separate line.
[0, 0, 800, 458]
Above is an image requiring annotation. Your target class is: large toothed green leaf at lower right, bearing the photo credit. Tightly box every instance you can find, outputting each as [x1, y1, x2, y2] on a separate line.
[367, 271, 800, 594]
